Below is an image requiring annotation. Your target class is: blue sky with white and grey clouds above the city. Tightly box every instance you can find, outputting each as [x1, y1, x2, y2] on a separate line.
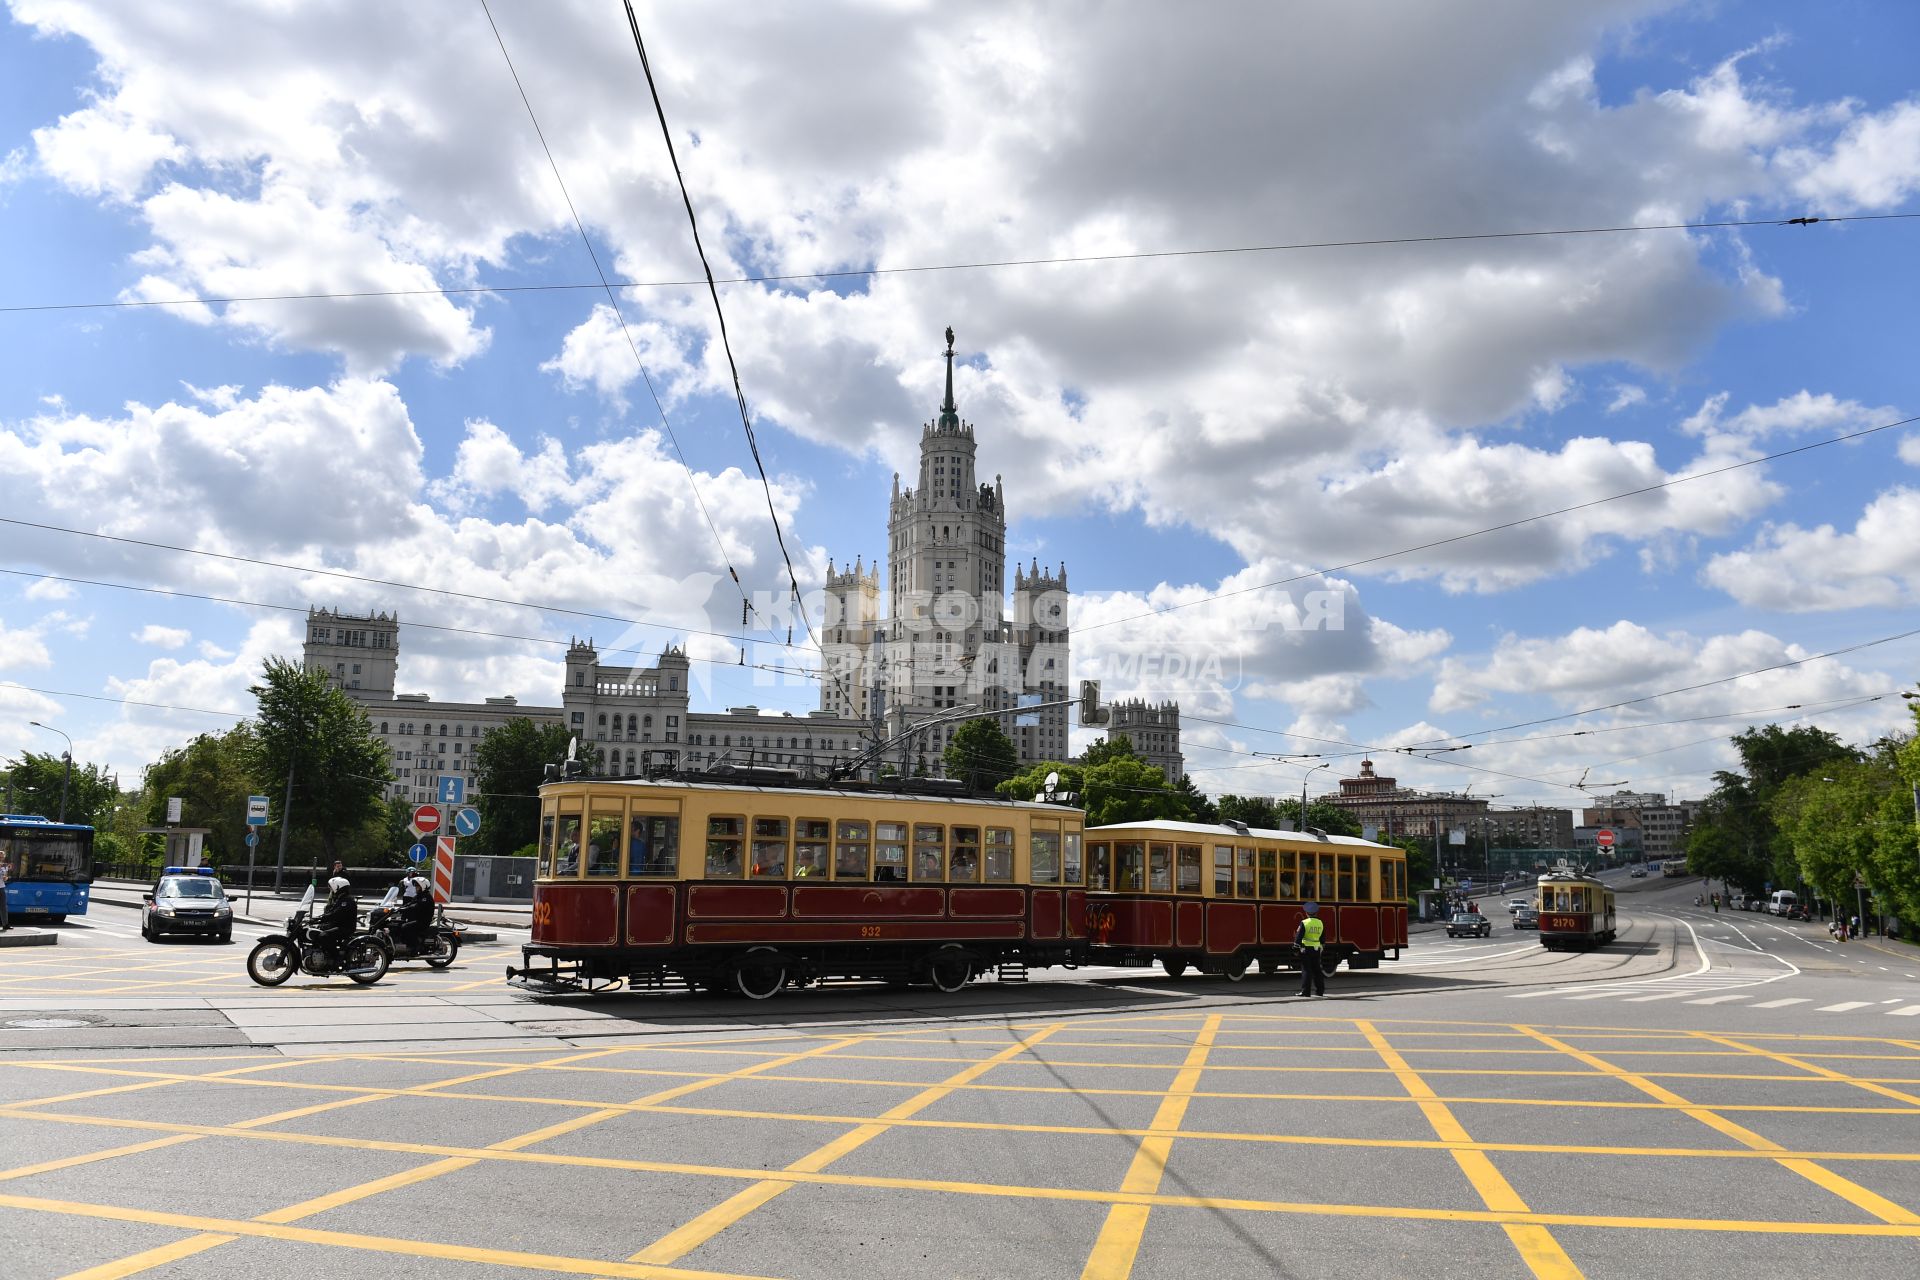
[0, 0, 1920, 806]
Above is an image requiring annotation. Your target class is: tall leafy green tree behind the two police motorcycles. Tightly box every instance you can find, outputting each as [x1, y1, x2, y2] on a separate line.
[248, 658, 394, 862]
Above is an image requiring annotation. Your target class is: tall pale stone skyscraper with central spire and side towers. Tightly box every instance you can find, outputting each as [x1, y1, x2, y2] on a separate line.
[820, 328, 1069, 773]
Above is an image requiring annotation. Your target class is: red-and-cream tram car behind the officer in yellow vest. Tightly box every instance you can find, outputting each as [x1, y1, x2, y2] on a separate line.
[1087, 821, 1407, 983]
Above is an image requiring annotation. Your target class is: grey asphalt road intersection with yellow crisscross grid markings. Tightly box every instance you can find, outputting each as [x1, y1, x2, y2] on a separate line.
[0, 879, 1920, 1280]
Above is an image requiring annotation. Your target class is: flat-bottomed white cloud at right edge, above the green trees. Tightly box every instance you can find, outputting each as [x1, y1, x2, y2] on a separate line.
[1701, 487, 1920, 614]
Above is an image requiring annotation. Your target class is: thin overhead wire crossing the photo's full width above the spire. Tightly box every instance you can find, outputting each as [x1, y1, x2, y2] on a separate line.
[0, 213, 1920, 315]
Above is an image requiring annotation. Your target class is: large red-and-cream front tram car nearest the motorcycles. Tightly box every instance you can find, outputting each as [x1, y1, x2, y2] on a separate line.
[507, 779, 1087, 1000]
